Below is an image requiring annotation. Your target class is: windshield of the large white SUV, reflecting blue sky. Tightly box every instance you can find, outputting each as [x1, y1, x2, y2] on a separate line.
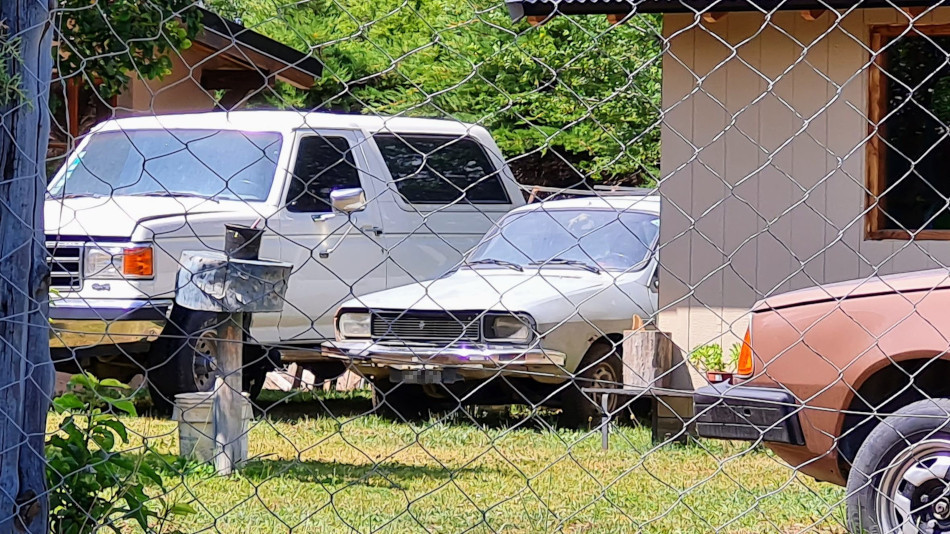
[48, 130, 281, 200]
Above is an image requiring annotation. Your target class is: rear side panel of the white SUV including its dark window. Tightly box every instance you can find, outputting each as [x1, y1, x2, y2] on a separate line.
[367, 132, 524, 287]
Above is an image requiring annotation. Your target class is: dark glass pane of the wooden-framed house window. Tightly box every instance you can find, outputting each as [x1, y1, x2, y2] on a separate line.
[881, 33, 950, 231]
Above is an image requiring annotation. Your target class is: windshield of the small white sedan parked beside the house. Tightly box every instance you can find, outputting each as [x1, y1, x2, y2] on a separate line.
[467, 209, 660, 271]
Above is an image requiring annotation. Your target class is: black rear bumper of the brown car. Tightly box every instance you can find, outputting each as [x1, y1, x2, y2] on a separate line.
[693, 382, 805, 445]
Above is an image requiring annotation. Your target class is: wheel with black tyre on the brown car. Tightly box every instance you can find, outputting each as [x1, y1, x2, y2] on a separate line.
[847, 399, 950, 534]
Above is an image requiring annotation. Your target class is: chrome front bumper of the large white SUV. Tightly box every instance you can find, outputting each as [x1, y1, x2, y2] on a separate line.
[49, 298, 172, 349]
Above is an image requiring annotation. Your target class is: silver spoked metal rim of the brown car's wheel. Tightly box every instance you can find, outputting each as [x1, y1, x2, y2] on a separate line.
[877, 437, 950, 534]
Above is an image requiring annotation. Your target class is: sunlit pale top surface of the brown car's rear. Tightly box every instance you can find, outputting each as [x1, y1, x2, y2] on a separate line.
[753, 269, 950, 311]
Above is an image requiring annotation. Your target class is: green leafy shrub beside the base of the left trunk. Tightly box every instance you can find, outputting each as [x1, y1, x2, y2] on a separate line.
[46, 375, 195, 534]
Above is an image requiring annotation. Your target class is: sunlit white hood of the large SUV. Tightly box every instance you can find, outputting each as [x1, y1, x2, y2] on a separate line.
[46, 196, 247, 237]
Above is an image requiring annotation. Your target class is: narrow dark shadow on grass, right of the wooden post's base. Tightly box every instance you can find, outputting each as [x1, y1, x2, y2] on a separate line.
[241, 459, 487, 489]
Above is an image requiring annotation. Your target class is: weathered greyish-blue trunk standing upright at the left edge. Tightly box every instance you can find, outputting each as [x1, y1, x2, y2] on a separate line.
[0, 0, 53, 534]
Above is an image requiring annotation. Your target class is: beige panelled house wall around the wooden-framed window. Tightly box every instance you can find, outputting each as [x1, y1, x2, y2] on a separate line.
[659, 8, 950, 356]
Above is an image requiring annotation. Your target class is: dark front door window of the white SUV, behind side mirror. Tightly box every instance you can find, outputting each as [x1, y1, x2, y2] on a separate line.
[287, 136, 360, 212]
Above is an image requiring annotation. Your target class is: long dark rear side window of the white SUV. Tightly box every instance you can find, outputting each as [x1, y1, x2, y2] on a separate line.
[374, 134, 508, 204]
